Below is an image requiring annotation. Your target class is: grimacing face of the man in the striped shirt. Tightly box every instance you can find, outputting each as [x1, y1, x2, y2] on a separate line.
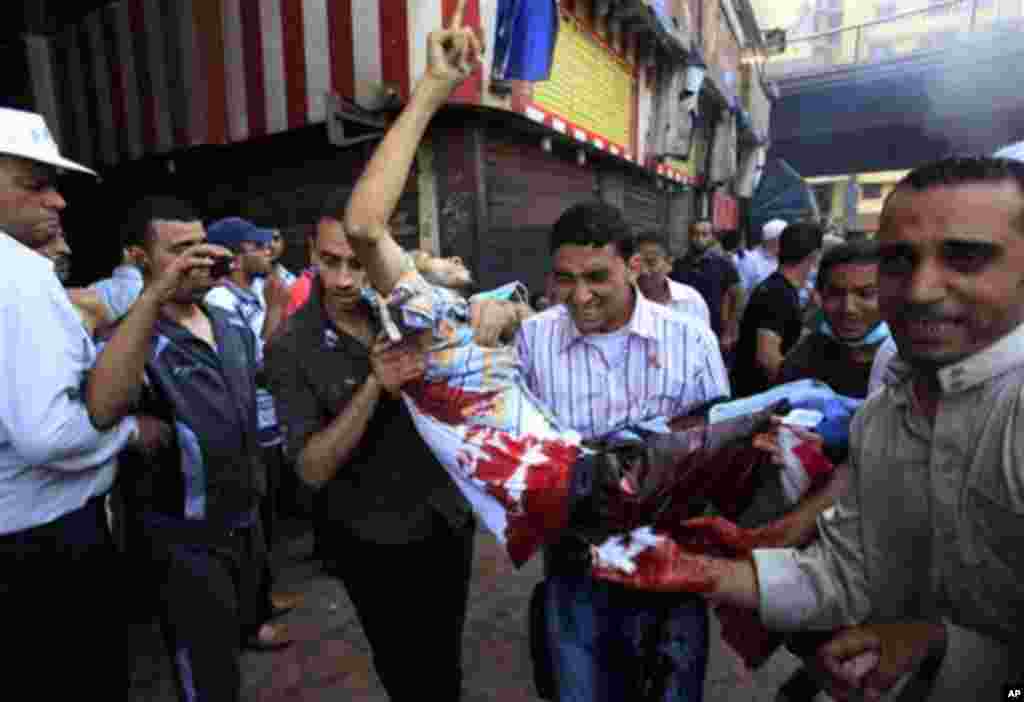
[553, 244, 633, 334]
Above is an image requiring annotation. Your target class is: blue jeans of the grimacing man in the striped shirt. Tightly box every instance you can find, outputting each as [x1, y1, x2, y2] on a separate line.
[547, 574, 709, 702]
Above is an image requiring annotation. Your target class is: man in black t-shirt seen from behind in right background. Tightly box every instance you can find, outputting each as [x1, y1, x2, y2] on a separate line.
[733, 223, 821, 397]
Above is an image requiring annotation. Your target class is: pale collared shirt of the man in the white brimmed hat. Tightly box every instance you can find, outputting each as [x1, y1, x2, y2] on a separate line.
[0, 232, 137, 533]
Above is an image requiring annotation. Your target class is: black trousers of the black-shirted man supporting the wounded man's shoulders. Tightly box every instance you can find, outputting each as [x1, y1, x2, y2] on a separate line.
[325, 514, 474, 702]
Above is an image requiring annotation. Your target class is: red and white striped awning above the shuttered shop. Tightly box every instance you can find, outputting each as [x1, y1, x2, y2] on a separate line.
[28, 0, 498, 166]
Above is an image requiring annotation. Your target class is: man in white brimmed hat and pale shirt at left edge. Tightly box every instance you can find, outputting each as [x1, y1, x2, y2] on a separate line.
[0, 108, 160, 700]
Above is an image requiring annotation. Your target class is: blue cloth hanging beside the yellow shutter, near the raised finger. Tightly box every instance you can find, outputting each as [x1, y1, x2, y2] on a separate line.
[492, 0, 559, 81]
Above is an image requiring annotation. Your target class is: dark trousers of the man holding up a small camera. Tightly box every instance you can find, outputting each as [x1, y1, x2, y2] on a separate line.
[133, 515, 270, 702]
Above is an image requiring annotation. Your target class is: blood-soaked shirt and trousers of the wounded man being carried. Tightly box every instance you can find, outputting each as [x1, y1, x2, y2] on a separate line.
[366, 252, 851, 565]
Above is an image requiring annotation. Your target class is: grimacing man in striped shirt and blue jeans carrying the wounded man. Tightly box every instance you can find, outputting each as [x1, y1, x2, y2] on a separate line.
[516, 203, 729, 702]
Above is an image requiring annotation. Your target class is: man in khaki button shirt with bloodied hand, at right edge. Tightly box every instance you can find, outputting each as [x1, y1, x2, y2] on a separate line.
[589, 159, 1024, 700]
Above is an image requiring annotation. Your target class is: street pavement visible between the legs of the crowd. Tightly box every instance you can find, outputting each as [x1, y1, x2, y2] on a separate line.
[125, 522, 797, 702]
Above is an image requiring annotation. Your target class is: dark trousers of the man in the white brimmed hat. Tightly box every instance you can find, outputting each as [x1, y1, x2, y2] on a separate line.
[0, 497, 132, 700]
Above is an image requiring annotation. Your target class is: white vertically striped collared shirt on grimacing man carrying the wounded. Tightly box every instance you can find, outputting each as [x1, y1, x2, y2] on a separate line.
[516, 293, 729, 438]
